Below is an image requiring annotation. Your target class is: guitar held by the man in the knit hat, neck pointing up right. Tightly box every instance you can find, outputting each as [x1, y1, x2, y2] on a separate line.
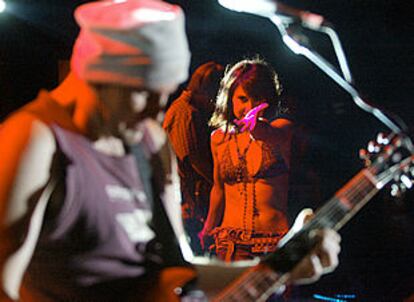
[148, 135, 414, 302]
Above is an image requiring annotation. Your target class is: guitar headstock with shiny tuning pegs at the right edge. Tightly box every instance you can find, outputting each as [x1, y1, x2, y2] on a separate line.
[359, 133, 414, 197]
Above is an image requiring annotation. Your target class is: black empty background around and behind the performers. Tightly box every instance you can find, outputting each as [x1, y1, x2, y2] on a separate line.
[0, 0, 414, 301]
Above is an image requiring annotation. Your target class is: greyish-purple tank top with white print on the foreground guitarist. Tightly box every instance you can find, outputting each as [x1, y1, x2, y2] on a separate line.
[24, 125, 157, 301]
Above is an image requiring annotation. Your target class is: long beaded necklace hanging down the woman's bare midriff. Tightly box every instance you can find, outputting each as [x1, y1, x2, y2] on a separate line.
[234, 133, 259, 240]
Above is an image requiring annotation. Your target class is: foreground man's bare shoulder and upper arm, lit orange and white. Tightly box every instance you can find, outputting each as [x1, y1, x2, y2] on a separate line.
[0, 112, 56, 223]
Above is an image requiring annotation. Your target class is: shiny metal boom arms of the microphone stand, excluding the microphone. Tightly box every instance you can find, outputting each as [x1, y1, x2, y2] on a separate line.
[266, 14, 403, 134]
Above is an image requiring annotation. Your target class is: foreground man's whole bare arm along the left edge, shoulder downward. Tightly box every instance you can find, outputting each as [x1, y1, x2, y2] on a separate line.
[0, 113, 56, 299]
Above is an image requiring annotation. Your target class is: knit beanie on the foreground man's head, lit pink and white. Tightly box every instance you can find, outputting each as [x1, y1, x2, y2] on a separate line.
[71, 0, 190, 90]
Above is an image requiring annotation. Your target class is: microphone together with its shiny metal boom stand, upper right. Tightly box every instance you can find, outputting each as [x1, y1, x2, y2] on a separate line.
[218, 0, 414, 139]
